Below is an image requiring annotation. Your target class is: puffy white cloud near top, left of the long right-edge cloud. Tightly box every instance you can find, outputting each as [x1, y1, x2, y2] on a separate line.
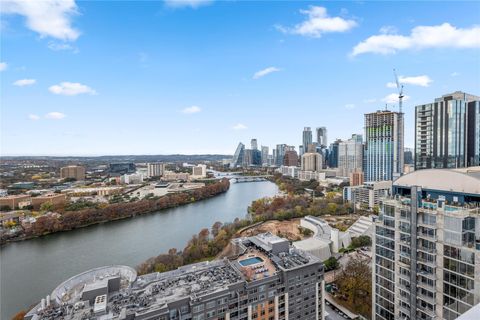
[276, 6, 357, 38]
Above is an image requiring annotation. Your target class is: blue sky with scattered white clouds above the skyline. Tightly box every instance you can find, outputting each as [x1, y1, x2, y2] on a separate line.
[0, 0, 480, 155]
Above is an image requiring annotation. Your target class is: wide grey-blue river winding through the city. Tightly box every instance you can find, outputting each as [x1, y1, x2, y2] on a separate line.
[0, 181, 278, 320]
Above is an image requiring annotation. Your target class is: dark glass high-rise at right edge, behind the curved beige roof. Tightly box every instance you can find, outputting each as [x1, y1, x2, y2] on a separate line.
[415, 91, 480, 170]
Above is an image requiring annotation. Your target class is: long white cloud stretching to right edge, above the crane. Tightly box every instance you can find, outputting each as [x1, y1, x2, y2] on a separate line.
[352, 23, 480, 56]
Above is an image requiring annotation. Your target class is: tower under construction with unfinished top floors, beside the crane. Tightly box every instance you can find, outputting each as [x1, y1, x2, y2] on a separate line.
[364, 110, 404, 181]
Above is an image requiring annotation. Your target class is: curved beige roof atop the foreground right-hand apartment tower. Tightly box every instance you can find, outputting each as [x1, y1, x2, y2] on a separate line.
[393, 167, 480, 194]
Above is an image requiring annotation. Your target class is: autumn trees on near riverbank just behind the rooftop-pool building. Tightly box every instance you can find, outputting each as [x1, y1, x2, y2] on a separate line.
[137, 218, 251, 275]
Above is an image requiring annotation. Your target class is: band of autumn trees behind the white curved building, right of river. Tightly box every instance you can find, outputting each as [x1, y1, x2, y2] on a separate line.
[248, 195, 353, 222]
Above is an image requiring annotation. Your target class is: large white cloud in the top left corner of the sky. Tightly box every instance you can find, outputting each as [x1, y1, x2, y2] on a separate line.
[0, 0, 80, 41]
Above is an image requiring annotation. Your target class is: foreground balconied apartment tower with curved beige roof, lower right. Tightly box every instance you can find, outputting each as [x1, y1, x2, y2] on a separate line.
[372, 167, 480, 320]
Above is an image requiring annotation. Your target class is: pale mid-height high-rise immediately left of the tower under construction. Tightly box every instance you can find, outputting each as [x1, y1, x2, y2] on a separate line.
[338, 135, 363, 177]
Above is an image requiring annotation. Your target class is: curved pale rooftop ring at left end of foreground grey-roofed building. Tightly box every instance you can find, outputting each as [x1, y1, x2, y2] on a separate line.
[51, 265, 137, 304]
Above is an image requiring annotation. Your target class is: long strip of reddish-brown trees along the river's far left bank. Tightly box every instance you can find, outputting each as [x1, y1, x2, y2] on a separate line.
[0, 179, 230, 245]
